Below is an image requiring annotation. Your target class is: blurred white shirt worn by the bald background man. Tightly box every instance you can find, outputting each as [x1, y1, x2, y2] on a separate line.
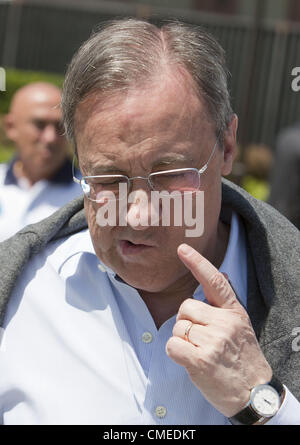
[0, 163, 81, 241]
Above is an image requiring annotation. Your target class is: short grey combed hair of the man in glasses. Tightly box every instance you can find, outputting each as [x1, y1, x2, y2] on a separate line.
[62, 19, 233, 146]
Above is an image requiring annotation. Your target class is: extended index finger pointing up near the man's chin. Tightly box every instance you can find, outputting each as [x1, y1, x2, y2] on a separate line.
[177, 244, 241, 308]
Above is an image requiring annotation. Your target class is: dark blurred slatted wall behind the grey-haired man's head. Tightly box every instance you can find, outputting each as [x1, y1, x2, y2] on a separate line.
[0, 0, 300, 154]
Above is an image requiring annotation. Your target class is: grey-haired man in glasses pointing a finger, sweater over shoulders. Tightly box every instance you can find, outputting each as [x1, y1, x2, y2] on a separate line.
[0, 19, 300, 425]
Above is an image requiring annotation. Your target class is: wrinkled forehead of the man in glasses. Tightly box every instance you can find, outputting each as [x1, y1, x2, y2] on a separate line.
[75, 72, 212, 155]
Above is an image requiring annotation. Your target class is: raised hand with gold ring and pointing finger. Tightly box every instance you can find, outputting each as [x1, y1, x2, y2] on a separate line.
[166, 244, 272, 417]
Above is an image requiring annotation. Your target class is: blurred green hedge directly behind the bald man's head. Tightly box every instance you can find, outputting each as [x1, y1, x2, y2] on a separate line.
[0, 68, 64, 163]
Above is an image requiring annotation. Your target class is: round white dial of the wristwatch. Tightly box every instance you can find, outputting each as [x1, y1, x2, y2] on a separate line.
[251, 385, 280, 417]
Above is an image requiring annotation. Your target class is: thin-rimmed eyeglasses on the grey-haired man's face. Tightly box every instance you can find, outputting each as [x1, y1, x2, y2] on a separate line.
[72, 134, 220, 203]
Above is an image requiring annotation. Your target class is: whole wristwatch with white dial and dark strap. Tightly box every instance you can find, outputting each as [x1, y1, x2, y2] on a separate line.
[229, 376, 284, 425]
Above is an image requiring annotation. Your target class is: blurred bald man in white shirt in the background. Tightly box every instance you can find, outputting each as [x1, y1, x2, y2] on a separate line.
[0, 82, 80, 241]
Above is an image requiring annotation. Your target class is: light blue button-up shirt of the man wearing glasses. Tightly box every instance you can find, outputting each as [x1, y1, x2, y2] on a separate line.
[0, 215, 300, 425]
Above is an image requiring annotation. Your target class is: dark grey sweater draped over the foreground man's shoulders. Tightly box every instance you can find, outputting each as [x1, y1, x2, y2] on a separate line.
[0, 180, 300, 400]
